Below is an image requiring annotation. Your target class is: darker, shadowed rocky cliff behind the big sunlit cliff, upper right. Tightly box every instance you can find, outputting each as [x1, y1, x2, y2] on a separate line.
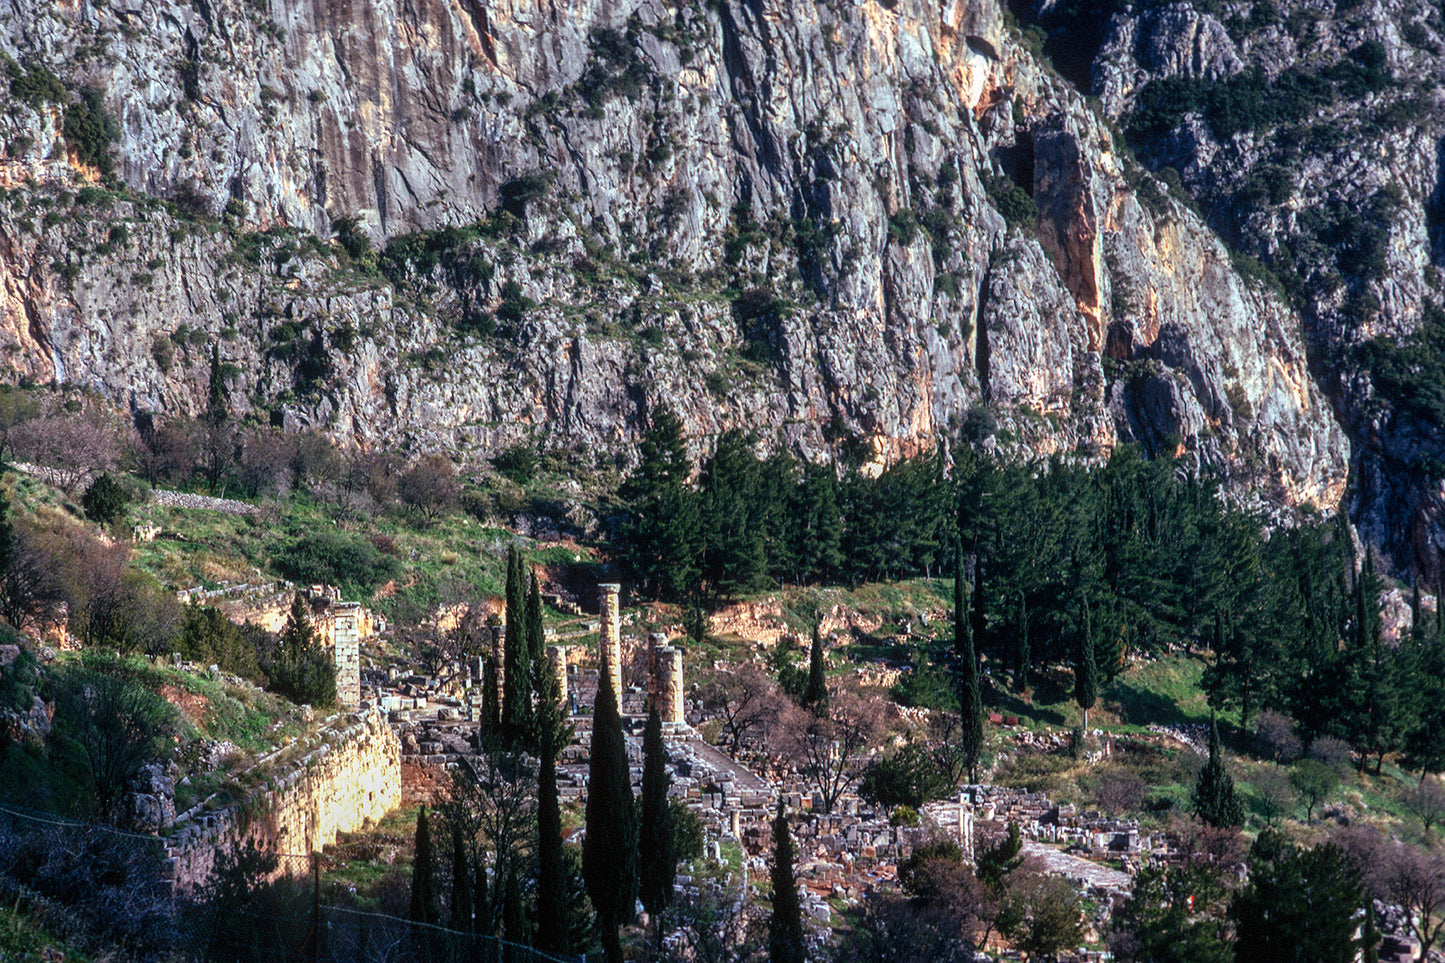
[1086, 0, 1445, 569]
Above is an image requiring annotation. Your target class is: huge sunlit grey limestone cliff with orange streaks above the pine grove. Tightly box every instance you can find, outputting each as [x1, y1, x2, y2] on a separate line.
[0, 0, 1348, 517]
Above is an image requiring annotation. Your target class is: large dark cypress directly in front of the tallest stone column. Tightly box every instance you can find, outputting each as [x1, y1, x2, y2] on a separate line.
[582, 670, 637, 963]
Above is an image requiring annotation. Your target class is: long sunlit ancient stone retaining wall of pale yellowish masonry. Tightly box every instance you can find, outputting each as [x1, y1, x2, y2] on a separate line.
[166, 710, 402, 892]
